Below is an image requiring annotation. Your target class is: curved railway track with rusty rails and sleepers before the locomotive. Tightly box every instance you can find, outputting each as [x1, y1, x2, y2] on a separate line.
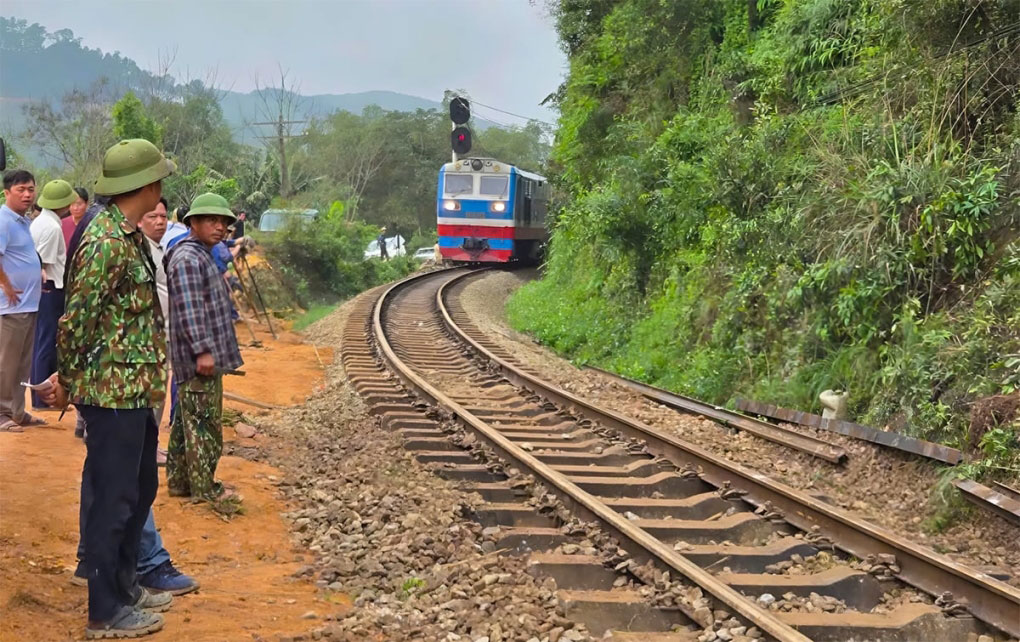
[342, 269, 1020, 642]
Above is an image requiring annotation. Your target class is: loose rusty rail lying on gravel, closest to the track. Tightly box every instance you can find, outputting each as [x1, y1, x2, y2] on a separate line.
[587, 365, 847, 463]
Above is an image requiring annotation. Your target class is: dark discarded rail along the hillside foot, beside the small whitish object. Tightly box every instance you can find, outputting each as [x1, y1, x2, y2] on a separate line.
[736, 399, 963, 465]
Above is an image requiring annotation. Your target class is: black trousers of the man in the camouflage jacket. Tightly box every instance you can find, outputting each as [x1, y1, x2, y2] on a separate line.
[78, 405, 159, 622]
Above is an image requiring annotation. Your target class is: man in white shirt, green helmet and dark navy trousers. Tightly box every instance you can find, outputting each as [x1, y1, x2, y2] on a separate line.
[29, 180, 78, 410]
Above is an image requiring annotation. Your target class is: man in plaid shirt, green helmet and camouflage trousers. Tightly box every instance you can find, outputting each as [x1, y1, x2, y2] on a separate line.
[165, 193, 243, 501]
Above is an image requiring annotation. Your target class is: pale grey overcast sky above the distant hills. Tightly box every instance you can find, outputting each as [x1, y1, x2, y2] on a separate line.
[0, 0, 566, 124]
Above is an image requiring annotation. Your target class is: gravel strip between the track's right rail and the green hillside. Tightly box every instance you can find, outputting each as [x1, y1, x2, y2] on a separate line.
[461, 270, 1020, 586]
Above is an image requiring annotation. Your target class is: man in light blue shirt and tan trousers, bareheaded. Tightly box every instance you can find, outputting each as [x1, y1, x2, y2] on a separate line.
[0, 169, 45, 433]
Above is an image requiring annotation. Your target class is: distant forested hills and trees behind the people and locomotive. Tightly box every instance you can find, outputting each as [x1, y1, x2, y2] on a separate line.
[0, 17, 549, 303]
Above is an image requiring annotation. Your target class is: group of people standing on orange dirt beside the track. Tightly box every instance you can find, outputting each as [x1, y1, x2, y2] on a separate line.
[0, 139, 243, 639]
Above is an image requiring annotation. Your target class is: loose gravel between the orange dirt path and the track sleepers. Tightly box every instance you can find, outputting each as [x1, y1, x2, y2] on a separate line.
[248, 291, 591, 642]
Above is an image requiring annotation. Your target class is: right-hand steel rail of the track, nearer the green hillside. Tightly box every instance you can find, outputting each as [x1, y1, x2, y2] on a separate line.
[437, 267, 1020, 637]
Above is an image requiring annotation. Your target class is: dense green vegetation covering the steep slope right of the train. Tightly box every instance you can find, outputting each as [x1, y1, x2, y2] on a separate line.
[509, 0, 1020, 478]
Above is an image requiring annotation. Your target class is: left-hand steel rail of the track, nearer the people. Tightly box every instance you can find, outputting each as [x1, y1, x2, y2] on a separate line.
[372, 273, 810, 642]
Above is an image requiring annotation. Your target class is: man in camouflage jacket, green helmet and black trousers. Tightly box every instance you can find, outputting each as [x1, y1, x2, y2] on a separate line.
[44, 139, 174, 639]
